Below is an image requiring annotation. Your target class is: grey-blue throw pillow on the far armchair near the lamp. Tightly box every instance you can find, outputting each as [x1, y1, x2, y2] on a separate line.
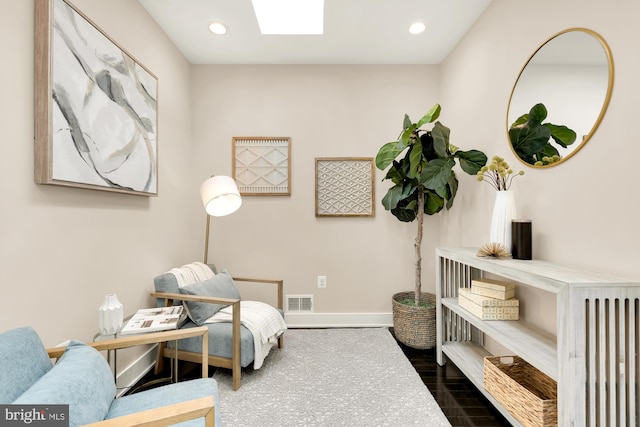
[179, 270, 240, 325]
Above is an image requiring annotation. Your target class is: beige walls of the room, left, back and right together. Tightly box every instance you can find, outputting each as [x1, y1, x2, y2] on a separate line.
[0, 0, 640, 345]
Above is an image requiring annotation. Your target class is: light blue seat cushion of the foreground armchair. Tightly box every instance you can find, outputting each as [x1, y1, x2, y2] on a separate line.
[106, 378, 222, 427]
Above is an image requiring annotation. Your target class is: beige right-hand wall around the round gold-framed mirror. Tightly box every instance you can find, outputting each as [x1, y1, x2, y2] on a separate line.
[441, 0, 640, 278]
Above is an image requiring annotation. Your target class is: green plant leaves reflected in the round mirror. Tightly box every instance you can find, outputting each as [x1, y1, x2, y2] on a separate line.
[509, 103, 576, 166]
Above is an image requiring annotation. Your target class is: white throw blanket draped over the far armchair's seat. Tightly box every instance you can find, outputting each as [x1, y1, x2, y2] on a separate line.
[205, 301, 287, 369]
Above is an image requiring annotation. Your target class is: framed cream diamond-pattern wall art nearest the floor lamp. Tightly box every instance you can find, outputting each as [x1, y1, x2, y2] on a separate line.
[231, 136, 291, 196]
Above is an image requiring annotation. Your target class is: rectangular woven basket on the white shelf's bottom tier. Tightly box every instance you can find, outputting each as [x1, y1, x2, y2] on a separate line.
[484, 356, 558, 427]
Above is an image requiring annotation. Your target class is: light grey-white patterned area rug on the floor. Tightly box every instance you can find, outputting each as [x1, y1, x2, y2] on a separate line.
[213, 328, 451, 427]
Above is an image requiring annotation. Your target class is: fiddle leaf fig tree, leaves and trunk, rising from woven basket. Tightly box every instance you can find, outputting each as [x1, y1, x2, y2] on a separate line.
[376, 104, 487, 306]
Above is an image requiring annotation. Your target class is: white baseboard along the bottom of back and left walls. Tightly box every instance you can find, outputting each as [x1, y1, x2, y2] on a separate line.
[117, 313, 393, 397]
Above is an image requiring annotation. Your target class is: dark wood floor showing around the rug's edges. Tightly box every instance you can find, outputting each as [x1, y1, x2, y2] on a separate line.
[133, 329, 511, 427]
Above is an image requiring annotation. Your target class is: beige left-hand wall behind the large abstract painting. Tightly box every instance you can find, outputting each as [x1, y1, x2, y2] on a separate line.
[0, 0, 200, 346]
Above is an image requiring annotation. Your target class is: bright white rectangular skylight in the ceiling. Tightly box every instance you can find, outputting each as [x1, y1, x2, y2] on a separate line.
[251, 0, 324, 35]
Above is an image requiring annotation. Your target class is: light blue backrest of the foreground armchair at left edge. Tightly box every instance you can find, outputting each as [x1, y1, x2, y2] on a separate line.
[0, 326, 52, 404]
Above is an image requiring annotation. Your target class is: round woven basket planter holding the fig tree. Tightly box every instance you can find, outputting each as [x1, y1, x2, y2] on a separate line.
[392, 292, 436, 350]
